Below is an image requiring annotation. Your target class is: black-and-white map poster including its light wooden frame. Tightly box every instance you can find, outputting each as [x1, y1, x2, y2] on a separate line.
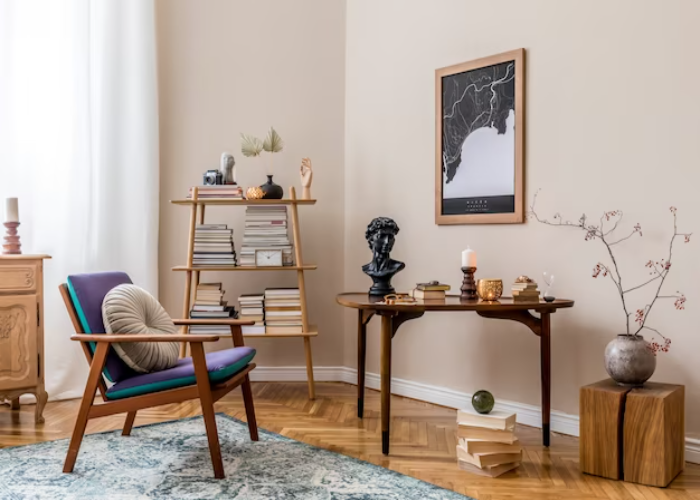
[435, 49, 525, 224]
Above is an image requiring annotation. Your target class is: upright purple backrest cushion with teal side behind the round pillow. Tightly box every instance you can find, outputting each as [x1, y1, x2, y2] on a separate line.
[66, 272, 136, 382]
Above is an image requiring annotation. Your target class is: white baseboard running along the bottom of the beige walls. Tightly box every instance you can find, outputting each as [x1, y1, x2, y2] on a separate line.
[250, 366, 700, 464]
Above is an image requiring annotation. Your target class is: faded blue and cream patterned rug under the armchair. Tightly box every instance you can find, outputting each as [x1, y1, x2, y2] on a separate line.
[0, 414, 468, 500]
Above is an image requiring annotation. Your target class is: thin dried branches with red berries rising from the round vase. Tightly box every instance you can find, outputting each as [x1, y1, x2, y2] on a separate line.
[528, 189, 692, 354]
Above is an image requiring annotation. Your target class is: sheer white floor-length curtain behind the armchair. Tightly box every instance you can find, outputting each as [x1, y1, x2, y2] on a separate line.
[0, 0, 159, 399]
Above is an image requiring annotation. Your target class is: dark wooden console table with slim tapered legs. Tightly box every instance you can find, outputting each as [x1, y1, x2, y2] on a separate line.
[336, 293, 574, 455]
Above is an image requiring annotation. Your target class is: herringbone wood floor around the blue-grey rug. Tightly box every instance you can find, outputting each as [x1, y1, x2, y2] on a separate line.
[0, 383, 700, 500]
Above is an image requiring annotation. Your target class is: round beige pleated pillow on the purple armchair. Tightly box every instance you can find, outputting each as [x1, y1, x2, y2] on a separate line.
[102, 284, 179, 373]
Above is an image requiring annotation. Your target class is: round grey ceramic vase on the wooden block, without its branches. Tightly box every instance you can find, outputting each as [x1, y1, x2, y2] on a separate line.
[605, 335, 656, 387]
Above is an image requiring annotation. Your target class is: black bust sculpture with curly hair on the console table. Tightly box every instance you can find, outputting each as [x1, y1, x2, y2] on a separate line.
[362, 217, 406, 296]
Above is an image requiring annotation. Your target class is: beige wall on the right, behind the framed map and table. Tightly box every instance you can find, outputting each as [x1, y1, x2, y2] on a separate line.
[344, 0, 700, 434]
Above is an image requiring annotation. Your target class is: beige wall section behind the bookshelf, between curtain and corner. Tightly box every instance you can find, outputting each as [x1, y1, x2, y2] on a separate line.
[157, 0, 345, 366]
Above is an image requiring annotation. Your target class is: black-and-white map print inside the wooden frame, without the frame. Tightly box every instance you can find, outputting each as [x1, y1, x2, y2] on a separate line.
[442, 61, 515, 215]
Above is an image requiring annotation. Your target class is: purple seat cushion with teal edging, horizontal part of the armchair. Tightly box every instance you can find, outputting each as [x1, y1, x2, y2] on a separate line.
[107, 347, 255, 399]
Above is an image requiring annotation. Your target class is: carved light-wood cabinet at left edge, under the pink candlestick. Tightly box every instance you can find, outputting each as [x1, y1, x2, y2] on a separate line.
[0, 255, 50, 423]
